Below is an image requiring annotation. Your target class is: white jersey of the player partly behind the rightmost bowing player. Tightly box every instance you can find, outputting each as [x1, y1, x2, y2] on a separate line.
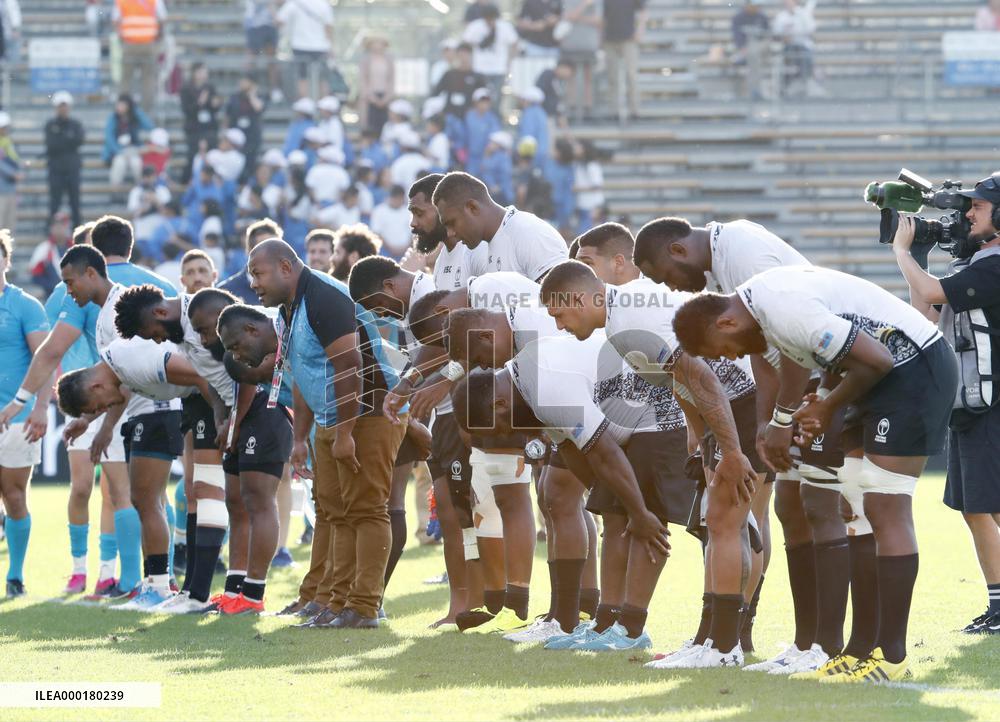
[705, 221, 809, 294]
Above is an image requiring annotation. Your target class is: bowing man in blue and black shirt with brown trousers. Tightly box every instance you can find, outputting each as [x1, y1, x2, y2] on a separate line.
[239, 240, 406, 628]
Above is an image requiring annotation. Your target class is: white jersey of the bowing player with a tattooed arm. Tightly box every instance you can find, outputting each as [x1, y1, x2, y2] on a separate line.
[604, 278, 755, 401]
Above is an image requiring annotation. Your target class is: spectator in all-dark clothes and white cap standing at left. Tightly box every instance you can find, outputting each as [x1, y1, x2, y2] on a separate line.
[45, 90, 84, 227]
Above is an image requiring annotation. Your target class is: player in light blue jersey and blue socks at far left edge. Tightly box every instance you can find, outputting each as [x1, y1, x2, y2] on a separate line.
[0, 230, 52, 597]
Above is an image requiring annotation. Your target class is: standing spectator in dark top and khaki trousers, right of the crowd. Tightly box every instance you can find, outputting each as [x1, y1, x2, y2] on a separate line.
[604, 0, 646, 120]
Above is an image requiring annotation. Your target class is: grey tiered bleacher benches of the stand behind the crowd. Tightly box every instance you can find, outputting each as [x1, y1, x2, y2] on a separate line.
[8, 0, 1000, 291]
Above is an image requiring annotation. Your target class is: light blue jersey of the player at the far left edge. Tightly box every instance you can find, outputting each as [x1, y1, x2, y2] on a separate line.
[0, 283, 49, 424]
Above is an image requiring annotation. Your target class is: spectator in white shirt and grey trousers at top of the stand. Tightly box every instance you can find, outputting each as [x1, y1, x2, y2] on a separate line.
[275, 0, 333, 98]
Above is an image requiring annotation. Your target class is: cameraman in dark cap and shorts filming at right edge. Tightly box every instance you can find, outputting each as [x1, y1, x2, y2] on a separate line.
[892, 173, 1000, 634]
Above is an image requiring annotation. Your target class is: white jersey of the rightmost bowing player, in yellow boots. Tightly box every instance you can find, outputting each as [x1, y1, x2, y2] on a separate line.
[736, 266, 941, 370]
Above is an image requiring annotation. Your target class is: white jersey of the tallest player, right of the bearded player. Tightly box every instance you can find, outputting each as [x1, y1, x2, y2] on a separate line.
[487, 206, 569, 281]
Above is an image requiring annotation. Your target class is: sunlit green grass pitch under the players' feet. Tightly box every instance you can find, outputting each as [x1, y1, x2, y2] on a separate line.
[0, 477, 1000, 722]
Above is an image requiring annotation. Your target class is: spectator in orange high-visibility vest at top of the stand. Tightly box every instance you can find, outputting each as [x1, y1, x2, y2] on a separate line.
[114, 0, 167, 108]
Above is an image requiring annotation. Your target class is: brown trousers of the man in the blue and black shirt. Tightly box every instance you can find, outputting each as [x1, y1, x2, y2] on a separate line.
[299, 416, 406, 617]
